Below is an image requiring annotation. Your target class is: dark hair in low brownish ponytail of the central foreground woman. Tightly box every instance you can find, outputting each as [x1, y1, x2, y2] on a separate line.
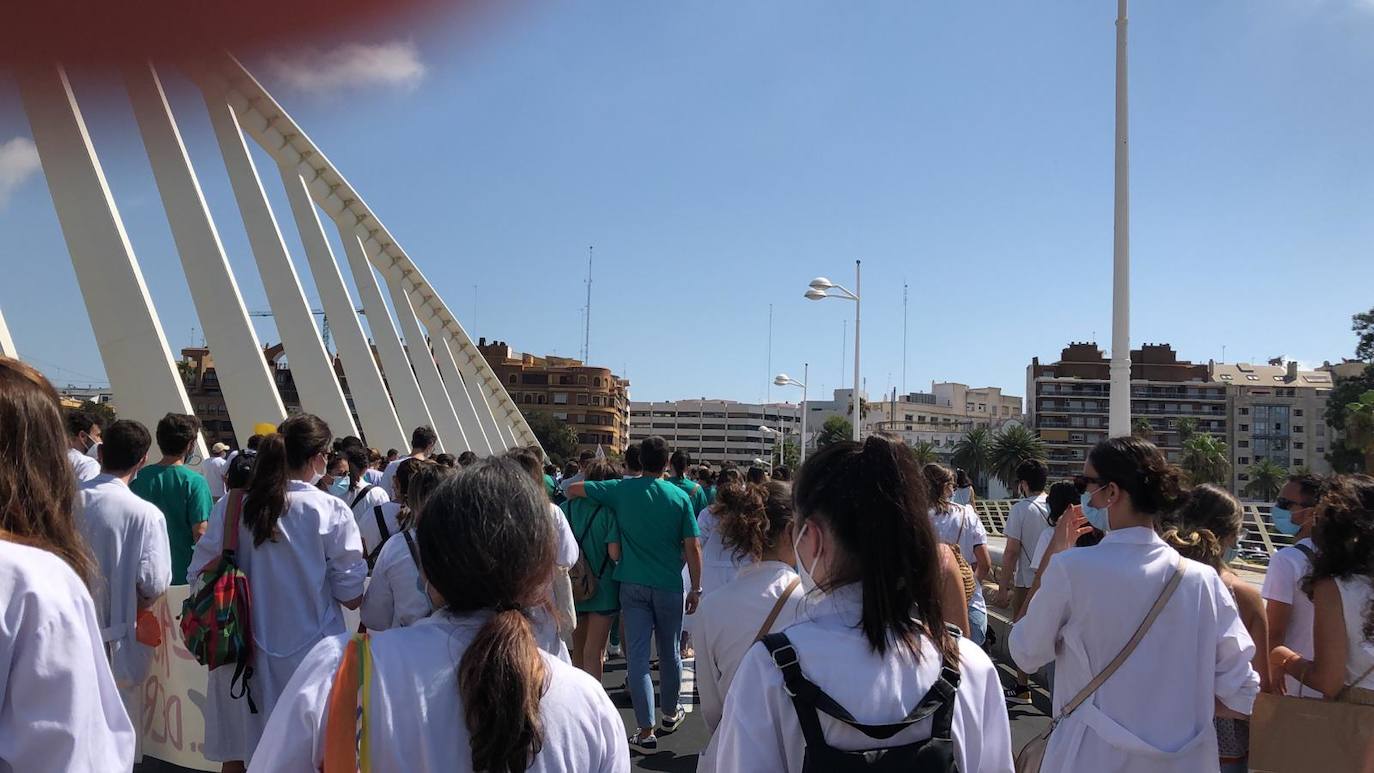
[416, 457, 555, 773]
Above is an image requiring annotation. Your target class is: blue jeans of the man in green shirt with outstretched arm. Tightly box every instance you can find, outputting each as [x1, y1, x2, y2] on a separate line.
[620, 582, 683, 729]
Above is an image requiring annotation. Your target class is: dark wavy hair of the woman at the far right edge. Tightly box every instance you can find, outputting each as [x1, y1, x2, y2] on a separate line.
[1304, 475, 1374, 641]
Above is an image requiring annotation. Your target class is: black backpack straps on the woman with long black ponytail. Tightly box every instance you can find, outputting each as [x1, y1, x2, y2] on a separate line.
[763, 633, 959, 747]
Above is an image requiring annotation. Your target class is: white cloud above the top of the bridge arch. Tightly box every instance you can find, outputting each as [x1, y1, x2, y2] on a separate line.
[267, 41, 425, 96]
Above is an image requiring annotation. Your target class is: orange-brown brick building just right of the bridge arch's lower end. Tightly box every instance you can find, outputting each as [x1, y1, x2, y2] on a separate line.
[477, 338, 631, 453]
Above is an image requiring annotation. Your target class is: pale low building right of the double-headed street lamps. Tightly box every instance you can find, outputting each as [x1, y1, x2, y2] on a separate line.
[864, 382, 1022, 457]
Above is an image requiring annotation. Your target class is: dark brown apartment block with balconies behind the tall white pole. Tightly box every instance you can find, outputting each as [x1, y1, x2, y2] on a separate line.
[1026, 342, 1230, 479]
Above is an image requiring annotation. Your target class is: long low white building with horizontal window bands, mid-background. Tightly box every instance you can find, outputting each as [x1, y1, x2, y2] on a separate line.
[629, 398, 819, 467]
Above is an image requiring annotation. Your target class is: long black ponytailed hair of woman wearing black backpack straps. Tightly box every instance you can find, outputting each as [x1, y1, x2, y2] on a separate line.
[794, 437, 954, 658]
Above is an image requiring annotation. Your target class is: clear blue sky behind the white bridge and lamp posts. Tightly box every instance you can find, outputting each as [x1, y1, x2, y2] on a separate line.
[0, 0, 1374, 409]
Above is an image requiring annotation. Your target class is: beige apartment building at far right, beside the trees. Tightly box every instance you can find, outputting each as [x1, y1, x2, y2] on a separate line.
[1209, 362, 1333, 496]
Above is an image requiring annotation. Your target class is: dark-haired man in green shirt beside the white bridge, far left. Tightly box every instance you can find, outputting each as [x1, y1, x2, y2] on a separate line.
[129, 413, 214, 584]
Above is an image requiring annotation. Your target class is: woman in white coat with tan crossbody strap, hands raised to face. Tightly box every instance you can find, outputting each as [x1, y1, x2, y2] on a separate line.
[1009, 438, 1260, 773]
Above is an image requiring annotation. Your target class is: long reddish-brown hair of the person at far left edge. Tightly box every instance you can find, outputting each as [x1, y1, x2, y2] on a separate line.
[0, 357, 96, 588]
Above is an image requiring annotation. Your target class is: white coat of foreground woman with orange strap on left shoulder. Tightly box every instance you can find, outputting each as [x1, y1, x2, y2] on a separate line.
[249, 612, 629, 773]
